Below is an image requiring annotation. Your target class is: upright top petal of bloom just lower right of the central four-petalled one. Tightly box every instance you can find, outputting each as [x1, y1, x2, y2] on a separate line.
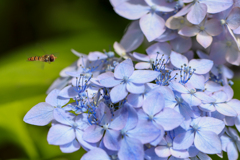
[143, 93, 164, 116]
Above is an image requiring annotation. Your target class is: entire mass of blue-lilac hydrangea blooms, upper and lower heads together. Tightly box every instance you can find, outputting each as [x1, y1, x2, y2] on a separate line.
[24, 0, 240, 160]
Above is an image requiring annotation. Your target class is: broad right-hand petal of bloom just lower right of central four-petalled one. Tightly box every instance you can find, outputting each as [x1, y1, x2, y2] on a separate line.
[154, 108, 184, 131]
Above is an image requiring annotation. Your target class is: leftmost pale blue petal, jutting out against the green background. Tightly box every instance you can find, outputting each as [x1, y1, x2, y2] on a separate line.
[23, 102, 54, 126]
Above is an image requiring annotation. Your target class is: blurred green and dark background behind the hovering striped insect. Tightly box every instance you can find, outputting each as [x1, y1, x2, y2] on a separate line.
[0, 0, 240, 160]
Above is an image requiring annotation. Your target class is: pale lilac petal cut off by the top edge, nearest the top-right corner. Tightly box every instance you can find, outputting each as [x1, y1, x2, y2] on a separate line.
[201, 0, 233, 13]
